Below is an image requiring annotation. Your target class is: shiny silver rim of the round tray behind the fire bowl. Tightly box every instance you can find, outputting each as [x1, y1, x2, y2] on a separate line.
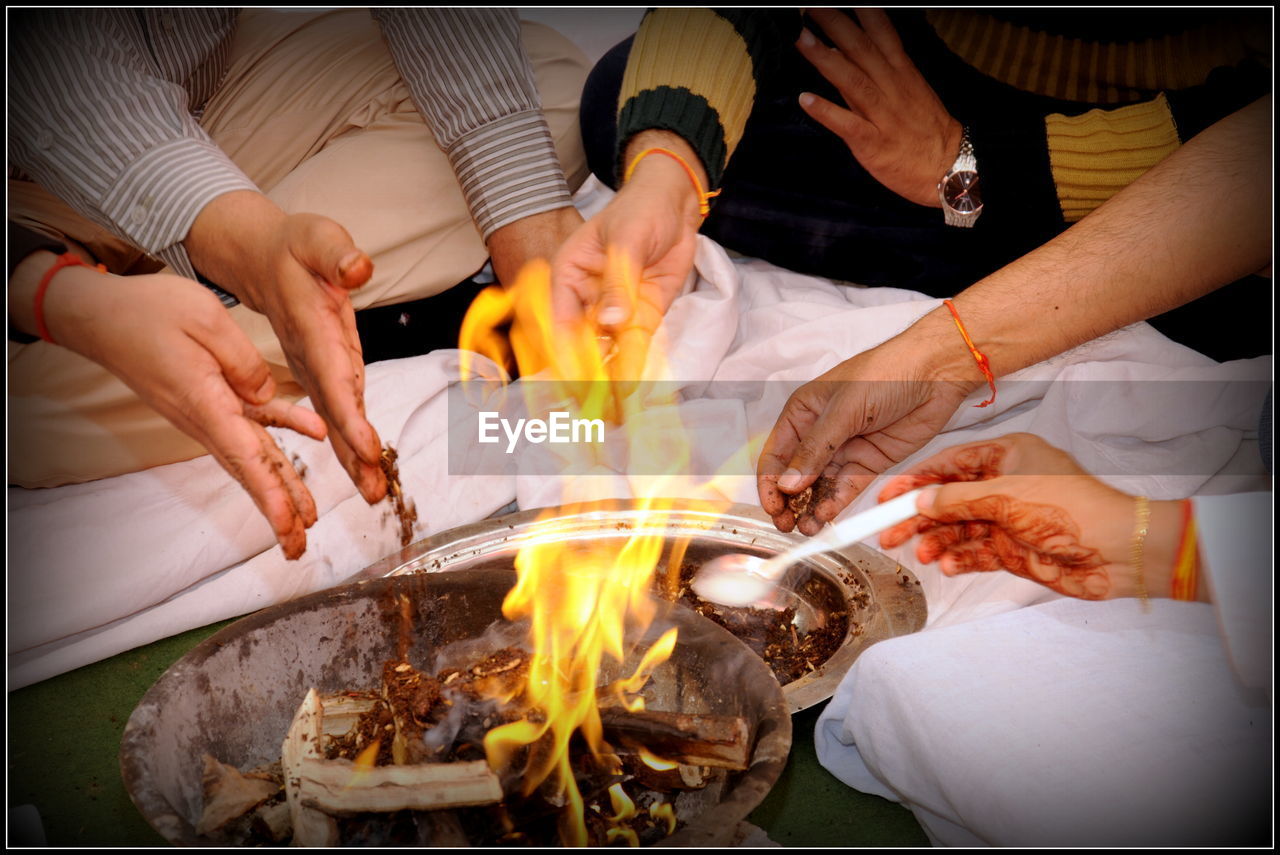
[353, 500, 927, 713]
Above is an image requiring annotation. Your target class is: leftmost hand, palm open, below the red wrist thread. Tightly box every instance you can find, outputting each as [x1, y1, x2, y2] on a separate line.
[36, 263, 325, 559]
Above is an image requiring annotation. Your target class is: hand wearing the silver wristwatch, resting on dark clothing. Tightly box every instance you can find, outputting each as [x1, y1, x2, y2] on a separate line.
[796, 9, 963, 207]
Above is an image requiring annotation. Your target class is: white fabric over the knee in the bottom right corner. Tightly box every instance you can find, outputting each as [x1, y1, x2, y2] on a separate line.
[814, 598, 1272, 846]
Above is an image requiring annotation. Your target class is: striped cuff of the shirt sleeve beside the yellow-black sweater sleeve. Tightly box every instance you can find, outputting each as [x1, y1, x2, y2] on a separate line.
[447, 110, 573, 242]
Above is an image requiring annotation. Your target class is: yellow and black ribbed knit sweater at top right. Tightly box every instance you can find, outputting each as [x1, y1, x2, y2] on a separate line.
[617, 9, 1271, 224]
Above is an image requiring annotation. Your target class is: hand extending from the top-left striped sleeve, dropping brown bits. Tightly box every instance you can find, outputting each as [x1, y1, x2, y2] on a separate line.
[186, 192, 387, 504]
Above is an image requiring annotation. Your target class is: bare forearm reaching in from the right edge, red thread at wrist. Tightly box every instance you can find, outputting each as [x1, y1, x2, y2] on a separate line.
[909, 97, 1271, 375]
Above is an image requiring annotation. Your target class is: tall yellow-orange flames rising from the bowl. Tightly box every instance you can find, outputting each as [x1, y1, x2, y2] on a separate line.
[461, 262, 727, 846]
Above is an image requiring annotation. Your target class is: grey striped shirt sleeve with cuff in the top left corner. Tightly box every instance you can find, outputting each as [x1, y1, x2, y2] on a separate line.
[8, 9, 256, 284]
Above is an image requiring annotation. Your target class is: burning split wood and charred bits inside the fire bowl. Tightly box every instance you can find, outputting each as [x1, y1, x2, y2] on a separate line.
[202, 648, 750, 846]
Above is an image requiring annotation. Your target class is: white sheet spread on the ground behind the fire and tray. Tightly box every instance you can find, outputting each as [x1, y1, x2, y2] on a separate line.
[8, 180, 1270, 701]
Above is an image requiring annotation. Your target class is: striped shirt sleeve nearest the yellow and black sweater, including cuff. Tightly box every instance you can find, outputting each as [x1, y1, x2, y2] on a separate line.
[372, 9, 572, 241]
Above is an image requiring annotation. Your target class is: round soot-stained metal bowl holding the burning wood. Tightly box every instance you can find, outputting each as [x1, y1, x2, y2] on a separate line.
[120, 567, 791, 846]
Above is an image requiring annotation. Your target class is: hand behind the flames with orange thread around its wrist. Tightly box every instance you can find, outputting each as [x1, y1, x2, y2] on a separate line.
[552, 131, 707, 380]
